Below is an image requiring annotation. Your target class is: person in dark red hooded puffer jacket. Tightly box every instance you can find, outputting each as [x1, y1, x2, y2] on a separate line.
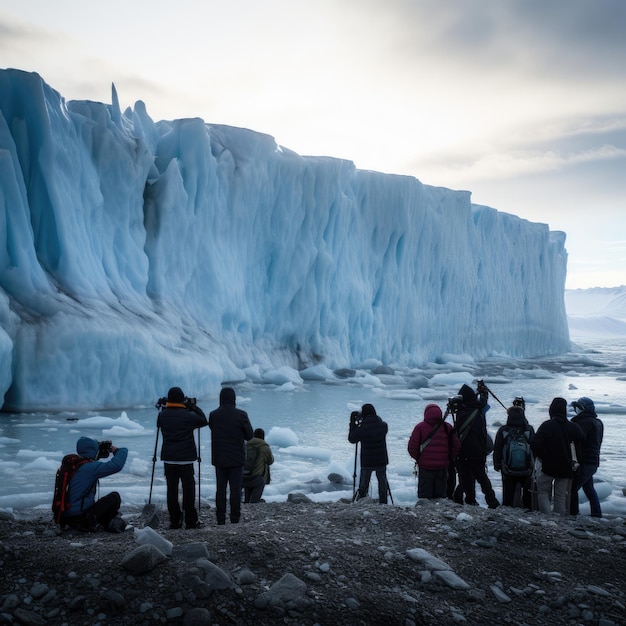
[408, 404, 461, 499]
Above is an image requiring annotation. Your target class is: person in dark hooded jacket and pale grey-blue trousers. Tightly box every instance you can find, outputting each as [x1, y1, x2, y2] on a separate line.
[531, 398, 584, 515]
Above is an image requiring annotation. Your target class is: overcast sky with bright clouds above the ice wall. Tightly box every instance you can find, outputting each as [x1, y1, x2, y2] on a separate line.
[0, 0, 626, 288]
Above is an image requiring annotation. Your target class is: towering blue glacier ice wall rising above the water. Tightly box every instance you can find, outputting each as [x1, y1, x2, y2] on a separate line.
[0, 70, 569, 410]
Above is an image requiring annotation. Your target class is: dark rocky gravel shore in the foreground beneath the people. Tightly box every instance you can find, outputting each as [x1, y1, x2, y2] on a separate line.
[0, 494, 626, 626]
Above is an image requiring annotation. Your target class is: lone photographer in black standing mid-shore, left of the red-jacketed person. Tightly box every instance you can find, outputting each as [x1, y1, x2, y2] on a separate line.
[348, 404, 389, 504]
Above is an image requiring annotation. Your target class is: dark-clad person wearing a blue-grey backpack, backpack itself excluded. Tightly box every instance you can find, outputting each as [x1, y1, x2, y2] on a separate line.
[493, 406, 535, 509]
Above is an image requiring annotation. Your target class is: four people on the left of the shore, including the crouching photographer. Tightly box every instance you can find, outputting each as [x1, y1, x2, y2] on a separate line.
[55, 387, 274, 532]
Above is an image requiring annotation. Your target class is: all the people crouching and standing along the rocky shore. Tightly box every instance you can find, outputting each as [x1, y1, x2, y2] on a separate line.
[55, 381, 604, 532]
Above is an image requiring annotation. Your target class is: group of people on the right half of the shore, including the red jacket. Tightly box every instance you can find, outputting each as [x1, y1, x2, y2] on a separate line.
[348, 381, 604, 517]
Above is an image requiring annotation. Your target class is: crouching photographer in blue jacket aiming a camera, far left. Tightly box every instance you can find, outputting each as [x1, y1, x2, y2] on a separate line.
[61, 437, 128, 532]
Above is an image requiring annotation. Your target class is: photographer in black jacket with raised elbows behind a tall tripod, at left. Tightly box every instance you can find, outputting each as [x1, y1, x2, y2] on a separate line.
[157, 387, 207, 528]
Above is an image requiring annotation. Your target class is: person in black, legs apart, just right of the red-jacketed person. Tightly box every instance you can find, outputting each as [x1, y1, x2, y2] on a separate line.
[454, 382, 500, 509]
